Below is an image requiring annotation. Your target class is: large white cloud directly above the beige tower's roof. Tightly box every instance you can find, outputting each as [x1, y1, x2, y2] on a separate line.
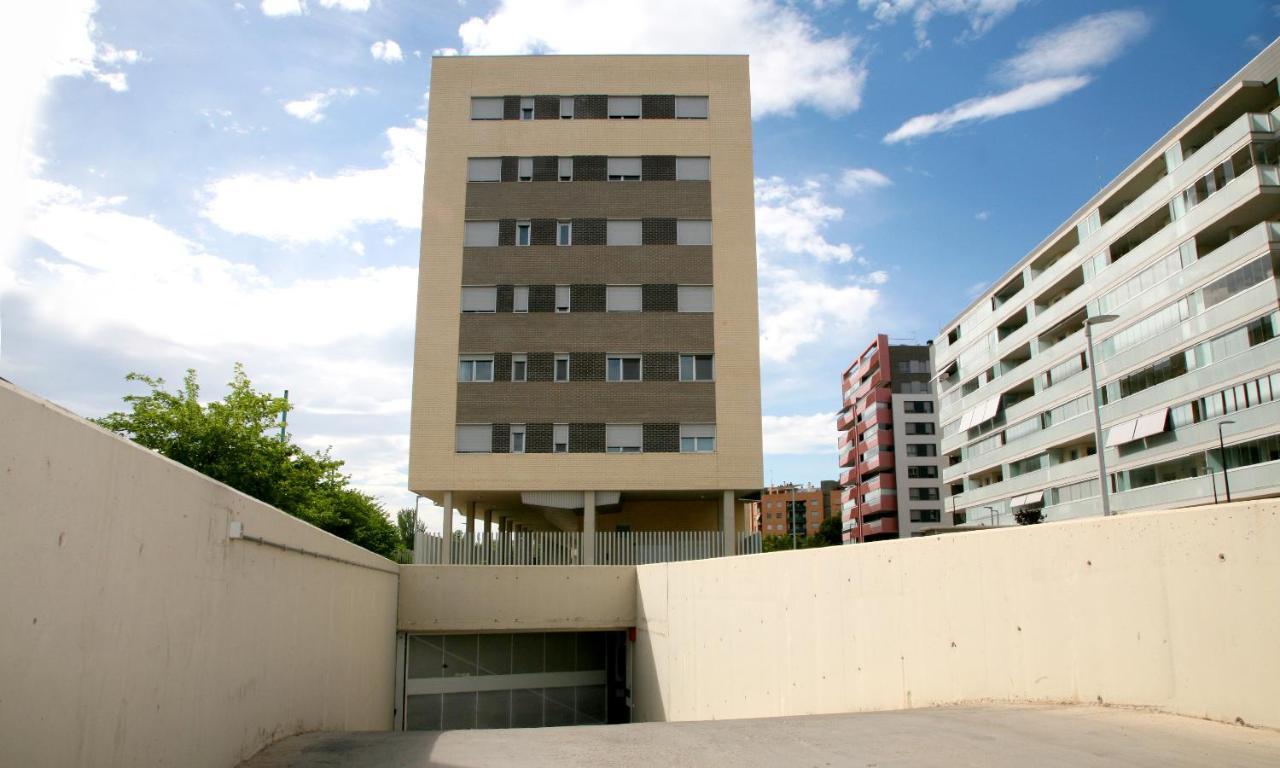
[458, 0, 867, 116]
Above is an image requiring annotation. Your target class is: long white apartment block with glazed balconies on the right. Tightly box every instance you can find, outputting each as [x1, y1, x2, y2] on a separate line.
[933, 42, 1280, 525]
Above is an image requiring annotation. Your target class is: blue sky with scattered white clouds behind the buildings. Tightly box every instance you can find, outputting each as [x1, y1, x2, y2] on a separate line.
[0, 0, 1280, 524]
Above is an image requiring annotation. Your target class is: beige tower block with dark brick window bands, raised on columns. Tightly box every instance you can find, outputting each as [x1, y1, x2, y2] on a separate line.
[410, 56, 763, 563]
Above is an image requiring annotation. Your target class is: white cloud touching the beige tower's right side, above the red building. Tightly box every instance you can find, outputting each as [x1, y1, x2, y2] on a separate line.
[755, 177, 887, 362]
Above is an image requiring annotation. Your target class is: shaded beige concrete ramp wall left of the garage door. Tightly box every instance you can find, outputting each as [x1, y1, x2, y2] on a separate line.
[0, 381, 397, 768]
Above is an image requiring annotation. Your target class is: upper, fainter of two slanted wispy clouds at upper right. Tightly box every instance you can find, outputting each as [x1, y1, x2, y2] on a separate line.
[998, 10, 1151, 83]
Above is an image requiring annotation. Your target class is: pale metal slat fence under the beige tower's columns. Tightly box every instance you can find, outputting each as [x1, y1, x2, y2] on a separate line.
[413, 531, 760, 566]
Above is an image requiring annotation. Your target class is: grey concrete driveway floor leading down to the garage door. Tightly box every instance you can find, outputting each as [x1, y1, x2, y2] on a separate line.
[241, 705, 1280, 768]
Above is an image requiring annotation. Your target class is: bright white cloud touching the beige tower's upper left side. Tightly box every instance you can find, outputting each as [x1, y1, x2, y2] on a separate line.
[201, 119, 426, 244]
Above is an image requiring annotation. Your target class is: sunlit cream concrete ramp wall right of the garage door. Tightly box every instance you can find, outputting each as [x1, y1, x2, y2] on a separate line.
[635, 500, 1280, 728]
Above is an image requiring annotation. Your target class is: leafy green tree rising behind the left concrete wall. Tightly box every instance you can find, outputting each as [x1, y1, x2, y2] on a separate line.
[93, 364, 403, 558]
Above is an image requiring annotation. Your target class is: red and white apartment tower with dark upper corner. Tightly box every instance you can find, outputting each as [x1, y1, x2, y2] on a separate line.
[836, 334, 946, 544]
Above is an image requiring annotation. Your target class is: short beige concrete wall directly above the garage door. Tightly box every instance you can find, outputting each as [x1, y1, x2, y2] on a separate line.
[398, 566, 636, 632]
